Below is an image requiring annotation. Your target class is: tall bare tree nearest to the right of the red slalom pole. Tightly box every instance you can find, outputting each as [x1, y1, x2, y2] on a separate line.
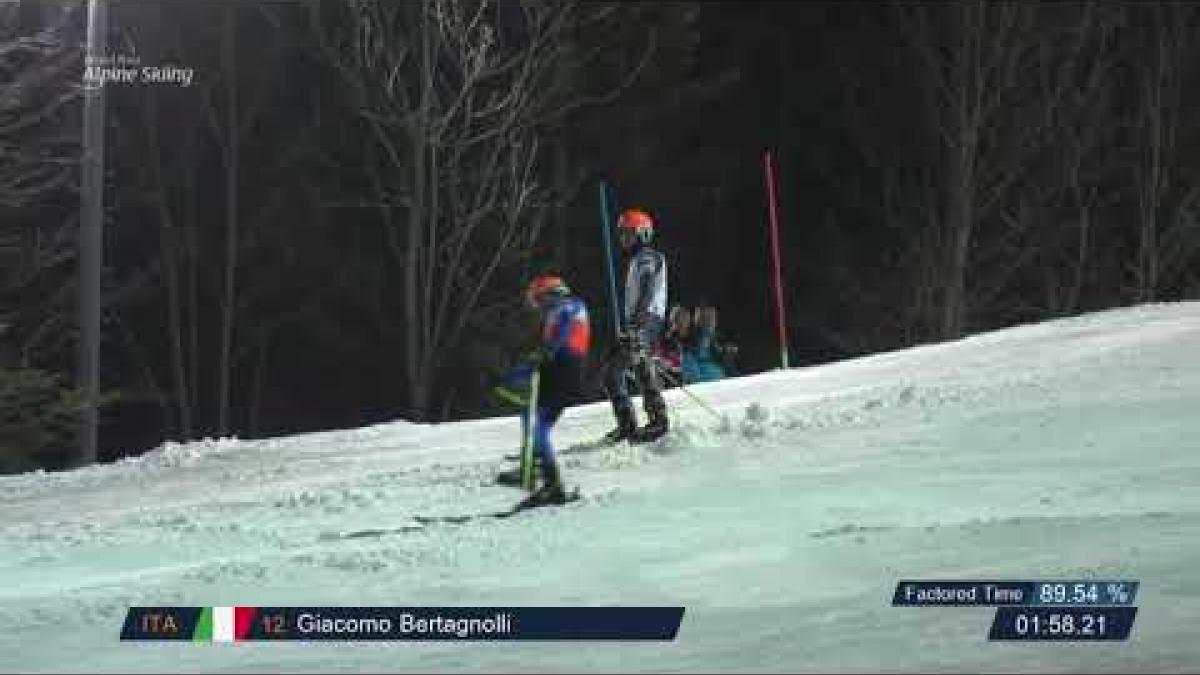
[822, 0, 1048, 344]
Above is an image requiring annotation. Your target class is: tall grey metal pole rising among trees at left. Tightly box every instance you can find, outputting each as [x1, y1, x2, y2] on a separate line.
[78, 0, 108, 465]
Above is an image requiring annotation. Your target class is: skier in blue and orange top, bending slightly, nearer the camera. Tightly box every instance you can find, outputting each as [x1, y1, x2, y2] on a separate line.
[502, 275, 592, 504]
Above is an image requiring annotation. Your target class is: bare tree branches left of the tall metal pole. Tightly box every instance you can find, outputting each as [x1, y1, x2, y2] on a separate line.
[0, 4, 80, 363]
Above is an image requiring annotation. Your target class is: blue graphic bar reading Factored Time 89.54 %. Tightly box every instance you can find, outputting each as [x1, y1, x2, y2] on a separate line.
[892, 579, 1138, 607]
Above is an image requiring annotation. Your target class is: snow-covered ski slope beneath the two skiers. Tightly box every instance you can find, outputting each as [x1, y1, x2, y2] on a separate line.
[0, 303, 1200, 671]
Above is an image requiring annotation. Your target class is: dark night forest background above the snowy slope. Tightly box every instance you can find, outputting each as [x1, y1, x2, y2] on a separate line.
[0, 0, 1200, 471]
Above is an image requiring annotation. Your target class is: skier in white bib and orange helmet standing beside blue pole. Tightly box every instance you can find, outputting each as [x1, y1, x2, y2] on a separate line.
[604, 209, 670, 442]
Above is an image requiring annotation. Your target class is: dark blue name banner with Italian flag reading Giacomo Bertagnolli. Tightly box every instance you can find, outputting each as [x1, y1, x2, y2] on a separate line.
[121, 607, 684, 643]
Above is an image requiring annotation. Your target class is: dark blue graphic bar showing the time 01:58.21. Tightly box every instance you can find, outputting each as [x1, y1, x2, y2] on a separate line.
[988, 607, 1138, 641]
